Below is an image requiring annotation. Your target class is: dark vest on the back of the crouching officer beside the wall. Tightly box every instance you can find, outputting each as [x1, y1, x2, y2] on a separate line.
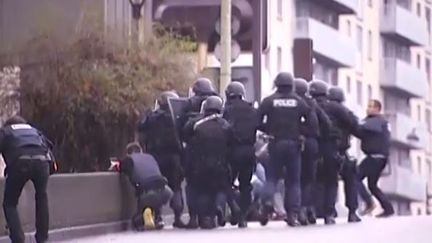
[129, 153, 163, 187]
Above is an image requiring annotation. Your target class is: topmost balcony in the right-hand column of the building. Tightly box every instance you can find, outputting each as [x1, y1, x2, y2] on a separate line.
[380, 4, 429, 46]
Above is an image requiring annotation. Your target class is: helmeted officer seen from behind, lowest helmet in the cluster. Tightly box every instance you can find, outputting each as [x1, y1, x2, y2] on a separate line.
[184, 96, 232, 229]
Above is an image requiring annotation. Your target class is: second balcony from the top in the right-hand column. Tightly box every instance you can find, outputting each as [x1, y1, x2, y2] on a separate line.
[380, 57, 429, 98]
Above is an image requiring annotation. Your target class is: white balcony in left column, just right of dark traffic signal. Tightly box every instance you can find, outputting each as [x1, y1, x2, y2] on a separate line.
[295, 17, 356, 67]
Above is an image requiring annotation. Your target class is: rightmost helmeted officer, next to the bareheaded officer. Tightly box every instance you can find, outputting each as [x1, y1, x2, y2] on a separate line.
[309, 80, 357, 224]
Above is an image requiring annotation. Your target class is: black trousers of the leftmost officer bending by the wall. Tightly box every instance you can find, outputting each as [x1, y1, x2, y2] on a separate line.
[3, 160, 50, 243]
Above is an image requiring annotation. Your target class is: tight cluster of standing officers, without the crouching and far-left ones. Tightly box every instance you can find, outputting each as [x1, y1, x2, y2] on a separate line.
[132, 73, 394, 229]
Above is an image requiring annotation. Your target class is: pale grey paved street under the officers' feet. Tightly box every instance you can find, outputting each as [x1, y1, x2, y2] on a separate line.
[63, 216, 432, 243]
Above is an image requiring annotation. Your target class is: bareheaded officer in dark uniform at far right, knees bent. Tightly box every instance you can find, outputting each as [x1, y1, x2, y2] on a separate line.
[358, 100, 394, 217]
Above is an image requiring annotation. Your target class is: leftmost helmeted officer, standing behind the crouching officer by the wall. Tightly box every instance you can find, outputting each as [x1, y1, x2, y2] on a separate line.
[138, 91, 185, 228]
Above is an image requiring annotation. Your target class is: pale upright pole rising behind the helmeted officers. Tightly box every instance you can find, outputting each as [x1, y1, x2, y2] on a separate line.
[219, 0, 232, 94]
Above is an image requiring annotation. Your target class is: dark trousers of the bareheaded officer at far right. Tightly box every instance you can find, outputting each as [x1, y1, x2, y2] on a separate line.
[358, 156, 394, 213]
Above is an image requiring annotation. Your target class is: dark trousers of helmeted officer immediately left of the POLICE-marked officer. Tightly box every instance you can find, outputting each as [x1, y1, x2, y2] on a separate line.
[229, 145, 256, 214]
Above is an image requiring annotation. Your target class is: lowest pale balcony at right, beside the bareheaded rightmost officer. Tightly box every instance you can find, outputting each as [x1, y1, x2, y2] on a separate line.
[380, 164, 427, 202]
